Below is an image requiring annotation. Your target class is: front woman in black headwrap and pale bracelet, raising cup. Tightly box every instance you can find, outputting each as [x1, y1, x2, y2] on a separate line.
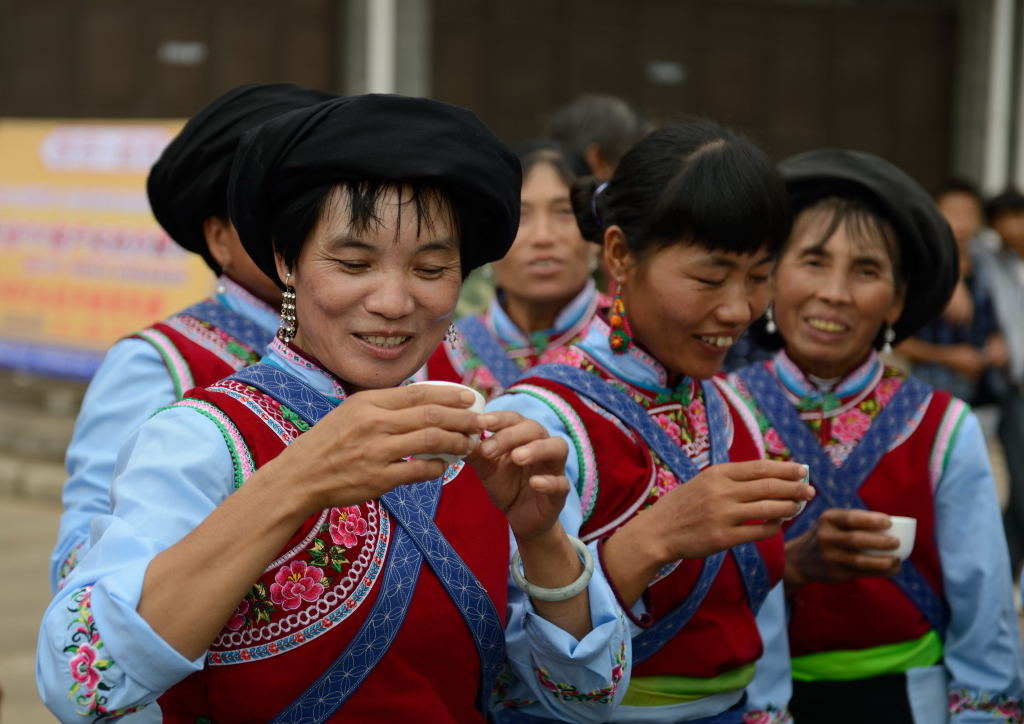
[38, 95, 626, 724]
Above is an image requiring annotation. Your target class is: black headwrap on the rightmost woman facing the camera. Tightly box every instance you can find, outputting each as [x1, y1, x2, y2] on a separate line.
[778, 148, 959, 341]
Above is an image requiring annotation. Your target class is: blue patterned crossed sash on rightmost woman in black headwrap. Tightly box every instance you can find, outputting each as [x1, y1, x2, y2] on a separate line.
[738, 364, 949, 637]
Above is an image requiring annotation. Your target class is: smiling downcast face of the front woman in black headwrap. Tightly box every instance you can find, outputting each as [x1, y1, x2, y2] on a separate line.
[278, 188, 462, 391]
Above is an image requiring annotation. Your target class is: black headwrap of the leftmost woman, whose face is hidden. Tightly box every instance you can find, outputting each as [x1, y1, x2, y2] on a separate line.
[145, 83, 335, 273]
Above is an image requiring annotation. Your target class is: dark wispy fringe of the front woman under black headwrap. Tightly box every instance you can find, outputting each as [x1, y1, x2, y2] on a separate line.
[272, 181, 458, 278]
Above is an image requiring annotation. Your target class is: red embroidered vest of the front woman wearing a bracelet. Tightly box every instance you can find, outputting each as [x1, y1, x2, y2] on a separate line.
[160, 381, 509, 724]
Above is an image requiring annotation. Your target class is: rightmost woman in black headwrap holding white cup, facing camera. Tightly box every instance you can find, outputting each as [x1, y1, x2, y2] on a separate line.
[730, 150, 1024, 724]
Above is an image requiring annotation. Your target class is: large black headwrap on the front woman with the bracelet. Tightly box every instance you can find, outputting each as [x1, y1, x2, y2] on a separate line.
[227, 94, 522, 284]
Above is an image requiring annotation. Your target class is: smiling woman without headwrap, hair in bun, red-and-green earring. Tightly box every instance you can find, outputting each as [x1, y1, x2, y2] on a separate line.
[492, 121, 813, 724]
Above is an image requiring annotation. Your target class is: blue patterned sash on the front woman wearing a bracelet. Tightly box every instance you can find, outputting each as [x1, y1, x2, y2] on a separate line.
[228, 363, 505, 724]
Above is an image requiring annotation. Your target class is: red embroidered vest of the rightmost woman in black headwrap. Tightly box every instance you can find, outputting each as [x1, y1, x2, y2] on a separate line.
[733, 370, 946, 656]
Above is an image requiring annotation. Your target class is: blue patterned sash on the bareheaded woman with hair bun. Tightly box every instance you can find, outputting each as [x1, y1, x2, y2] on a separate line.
[528, 365, 771, 663]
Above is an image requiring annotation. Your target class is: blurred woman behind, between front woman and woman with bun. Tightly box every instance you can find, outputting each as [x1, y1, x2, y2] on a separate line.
[425, 141, 608, 398]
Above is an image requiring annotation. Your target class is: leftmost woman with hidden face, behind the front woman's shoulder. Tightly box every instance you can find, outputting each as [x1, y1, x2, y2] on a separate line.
[50, 84, 333, 591]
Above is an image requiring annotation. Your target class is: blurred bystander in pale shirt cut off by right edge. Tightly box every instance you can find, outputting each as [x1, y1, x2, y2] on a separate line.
[975, 188, 1024, 576]
